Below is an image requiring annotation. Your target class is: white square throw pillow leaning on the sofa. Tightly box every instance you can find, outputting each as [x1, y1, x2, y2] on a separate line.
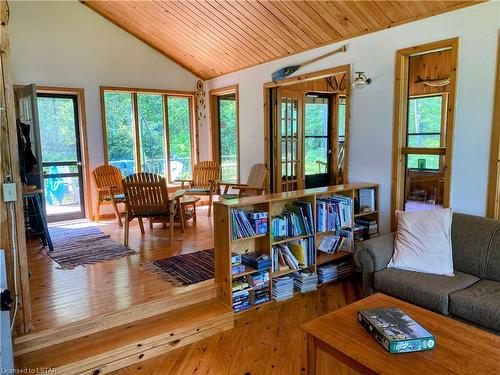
[387, 208, 453, 276]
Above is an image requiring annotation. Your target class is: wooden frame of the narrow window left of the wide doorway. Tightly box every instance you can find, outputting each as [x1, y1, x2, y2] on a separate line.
[208, 85, 241, 184]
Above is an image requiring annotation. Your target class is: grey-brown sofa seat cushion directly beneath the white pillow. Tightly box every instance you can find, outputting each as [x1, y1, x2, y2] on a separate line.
[374, 268, 479, 315]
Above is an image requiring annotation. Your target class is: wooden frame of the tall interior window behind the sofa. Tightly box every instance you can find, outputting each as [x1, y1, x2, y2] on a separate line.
[391, 38, 459, 230]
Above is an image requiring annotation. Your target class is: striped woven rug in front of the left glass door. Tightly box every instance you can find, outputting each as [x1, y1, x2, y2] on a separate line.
[47, 224, 136, 269]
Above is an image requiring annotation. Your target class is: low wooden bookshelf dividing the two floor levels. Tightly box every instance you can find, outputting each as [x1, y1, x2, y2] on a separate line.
[214, 183, 380, 313]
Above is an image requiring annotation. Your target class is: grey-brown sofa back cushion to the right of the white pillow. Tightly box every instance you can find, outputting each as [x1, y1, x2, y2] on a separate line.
[451, 213, 500, 278]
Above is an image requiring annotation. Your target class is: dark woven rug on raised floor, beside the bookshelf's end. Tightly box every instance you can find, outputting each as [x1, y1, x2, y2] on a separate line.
[144, 249, 215, 286]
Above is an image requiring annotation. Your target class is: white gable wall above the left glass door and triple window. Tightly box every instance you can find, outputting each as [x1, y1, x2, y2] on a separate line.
[9, 1, 198, 214]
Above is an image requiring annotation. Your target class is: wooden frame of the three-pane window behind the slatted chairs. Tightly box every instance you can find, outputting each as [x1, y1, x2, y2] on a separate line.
[99, 86, 199, 185]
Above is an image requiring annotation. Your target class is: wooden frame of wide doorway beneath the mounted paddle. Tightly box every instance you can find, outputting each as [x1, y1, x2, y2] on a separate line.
[262, 64, 351, 193]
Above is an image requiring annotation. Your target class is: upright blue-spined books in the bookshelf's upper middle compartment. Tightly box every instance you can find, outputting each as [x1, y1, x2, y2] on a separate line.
[271, 201, 314, 238]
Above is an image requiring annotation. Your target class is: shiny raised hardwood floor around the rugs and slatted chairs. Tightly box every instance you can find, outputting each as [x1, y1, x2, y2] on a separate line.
[28, 206, 213, 332]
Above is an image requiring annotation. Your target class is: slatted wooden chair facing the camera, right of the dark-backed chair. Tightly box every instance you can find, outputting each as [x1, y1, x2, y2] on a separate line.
[176, 160, 220, 216]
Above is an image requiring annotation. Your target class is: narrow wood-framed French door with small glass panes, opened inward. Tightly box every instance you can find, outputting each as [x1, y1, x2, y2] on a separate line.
[274, 88, 304, 192]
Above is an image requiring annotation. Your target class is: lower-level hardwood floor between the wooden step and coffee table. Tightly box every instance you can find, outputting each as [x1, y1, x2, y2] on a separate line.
[113, 281, 360, 375]
